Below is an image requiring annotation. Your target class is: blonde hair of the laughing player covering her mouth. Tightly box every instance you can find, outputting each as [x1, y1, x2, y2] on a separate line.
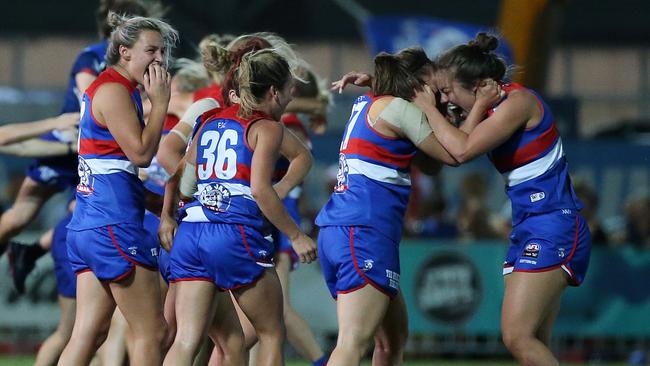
[106, 12, 178, 66]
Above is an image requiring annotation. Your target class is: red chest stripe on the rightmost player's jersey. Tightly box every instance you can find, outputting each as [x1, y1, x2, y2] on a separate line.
[491, 122, 559, 172]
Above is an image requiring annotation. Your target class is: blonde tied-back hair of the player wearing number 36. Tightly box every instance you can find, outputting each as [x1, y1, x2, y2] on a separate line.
[237, 48, 292, 117]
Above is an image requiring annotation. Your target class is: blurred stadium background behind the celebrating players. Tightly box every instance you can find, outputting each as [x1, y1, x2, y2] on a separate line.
[0, 0, 650, 364]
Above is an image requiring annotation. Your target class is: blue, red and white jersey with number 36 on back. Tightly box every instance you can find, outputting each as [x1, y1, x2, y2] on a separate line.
[182, 105, 272, 229]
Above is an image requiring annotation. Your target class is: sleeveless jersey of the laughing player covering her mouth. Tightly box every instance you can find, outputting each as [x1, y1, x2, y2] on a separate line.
[68, 68, 144, 230]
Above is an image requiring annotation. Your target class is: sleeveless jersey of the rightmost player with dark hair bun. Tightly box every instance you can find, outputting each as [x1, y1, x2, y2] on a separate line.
[488, 83, 582, 225]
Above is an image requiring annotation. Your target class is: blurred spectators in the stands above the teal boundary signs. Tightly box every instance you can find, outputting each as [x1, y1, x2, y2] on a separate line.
[306, 167, 650, 249]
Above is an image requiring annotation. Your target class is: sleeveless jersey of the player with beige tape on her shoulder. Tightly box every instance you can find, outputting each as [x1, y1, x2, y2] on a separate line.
[316, 95, 417, 242]
